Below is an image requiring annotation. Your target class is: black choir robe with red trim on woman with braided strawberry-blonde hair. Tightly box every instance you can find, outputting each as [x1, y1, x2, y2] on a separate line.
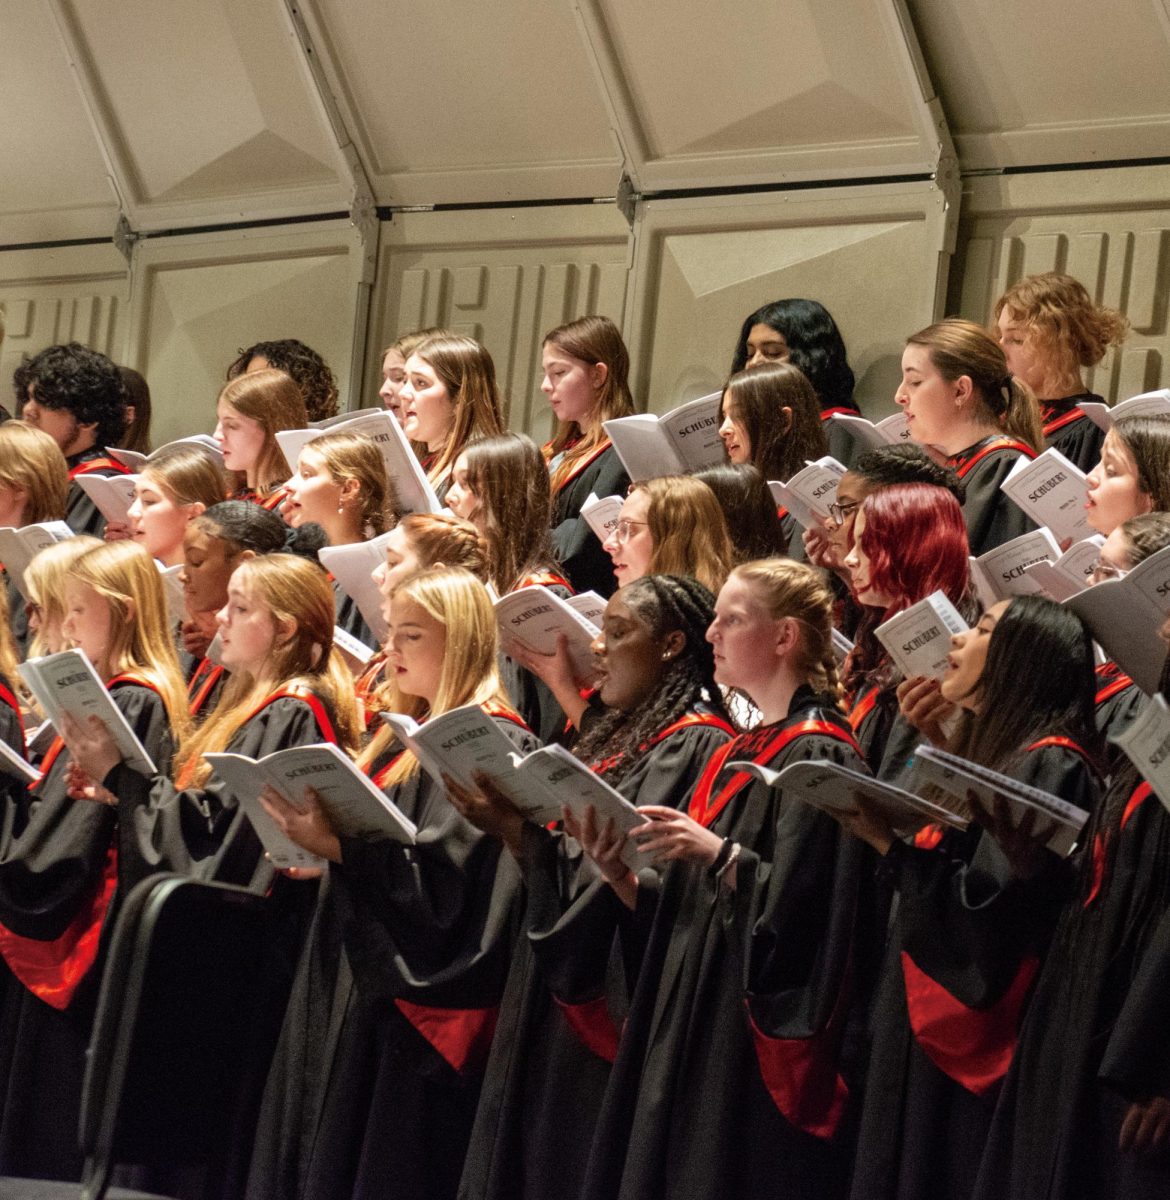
[582, 688, 864, 1200]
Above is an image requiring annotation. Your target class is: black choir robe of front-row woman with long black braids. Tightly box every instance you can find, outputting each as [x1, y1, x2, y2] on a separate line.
[460, 714, 731, 1200]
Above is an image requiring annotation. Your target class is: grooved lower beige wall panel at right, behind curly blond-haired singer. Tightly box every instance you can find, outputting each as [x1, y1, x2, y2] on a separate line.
[952, 167, 1170, 400]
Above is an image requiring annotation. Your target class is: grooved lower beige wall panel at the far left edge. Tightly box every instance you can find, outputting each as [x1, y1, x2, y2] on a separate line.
[0, 245, 130, 410]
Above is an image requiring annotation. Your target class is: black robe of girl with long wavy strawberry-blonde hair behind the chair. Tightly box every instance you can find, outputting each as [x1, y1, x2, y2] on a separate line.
[104, 696, 325, 888]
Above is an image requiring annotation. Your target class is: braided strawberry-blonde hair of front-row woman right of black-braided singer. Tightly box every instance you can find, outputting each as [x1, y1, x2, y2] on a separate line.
[730, 558, 845, 709]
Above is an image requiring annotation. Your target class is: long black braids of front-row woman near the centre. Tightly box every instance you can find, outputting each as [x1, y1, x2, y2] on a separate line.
[574, 575, 731, 785]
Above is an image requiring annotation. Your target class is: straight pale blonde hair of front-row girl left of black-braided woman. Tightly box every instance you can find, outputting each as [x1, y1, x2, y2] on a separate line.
[358, 566, 515, 786]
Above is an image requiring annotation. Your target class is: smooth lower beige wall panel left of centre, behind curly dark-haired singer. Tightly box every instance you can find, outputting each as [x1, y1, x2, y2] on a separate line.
[127, 222, 360, 444]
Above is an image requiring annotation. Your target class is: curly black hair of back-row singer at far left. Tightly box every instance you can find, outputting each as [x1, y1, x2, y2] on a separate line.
[12, 342, 127, 446]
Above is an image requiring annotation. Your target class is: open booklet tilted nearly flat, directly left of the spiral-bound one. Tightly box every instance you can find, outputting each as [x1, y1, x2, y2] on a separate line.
[727, 760, 970, 836]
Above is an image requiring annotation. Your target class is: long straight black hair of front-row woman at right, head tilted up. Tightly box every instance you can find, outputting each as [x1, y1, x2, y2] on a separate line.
[955, 595, 1100, 770]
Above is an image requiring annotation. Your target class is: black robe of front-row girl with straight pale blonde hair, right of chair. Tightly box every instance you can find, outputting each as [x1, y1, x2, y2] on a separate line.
[246, 716, 535, 1200]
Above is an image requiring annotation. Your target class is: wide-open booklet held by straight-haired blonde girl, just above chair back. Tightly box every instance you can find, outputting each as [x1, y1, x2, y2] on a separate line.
[204, 742, 418, 868]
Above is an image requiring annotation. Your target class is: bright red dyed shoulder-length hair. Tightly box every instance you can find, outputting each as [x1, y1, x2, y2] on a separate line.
[859, 484, 971, 619]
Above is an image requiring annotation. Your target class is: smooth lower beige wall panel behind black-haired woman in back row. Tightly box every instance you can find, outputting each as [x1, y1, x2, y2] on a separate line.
[629, 185, 948, 415]
